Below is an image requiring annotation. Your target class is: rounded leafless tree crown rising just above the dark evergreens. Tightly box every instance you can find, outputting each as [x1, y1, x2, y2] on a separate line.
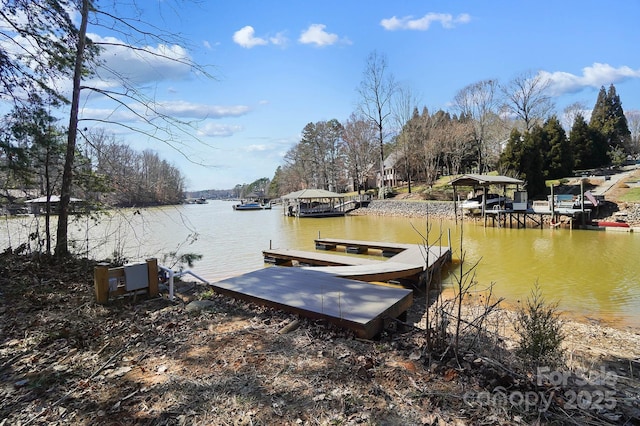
[502, 71, 554, 132]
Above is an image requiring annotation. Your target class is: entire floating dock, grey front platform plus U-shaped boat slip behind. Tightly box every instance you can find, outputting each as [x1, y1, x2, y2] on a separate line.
[211, 238, 451, 339]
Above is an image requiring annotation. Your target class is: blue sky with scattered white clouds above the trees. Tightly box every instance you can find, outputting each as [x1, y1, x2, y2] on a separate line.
[76, 0, 640, 190]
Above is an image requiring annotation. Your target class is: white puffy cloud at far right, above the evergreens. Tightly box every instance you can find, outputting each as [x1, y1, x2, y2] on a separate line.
[540, 62, 640, 96]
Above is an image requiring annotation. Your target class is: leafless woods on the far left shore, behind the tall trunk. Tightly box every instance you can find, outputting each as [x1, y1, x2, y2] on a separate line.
[0, 105, 185, 208]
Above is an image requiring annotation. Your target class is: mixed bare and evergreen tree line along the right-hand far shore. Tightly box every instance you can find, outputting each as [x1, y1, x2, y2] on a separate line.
[270, 52, 640, 197]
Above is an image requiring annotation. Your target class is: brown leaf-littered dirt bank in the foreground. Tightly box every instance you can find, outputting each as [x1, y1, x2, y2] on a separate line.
[0, 253, 640, 426]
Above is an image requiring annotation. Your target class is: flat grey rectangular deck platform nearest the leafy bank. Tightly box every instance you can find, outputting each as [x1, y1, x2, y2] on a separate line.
[211, 266, 413, 339]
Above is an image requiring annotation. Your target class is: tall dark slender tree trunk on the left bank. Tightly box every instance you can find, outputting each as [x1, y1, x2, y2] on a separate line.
[55, 0, 90, 257]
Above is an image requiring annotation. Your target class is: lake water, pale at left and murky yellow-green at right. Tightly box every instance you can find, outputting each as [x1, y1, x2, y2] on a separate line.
[0, 201, 640, 327]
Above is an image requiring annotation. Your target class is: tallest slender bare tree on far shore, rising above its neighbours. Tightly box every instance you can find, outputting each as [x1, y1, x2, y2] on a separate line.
[358, 51, 396, 198]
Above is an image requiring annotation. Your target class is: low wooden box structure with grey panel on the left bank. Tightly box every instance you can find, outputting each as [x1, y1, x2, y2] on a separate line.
[93, 259, 158, 304]
